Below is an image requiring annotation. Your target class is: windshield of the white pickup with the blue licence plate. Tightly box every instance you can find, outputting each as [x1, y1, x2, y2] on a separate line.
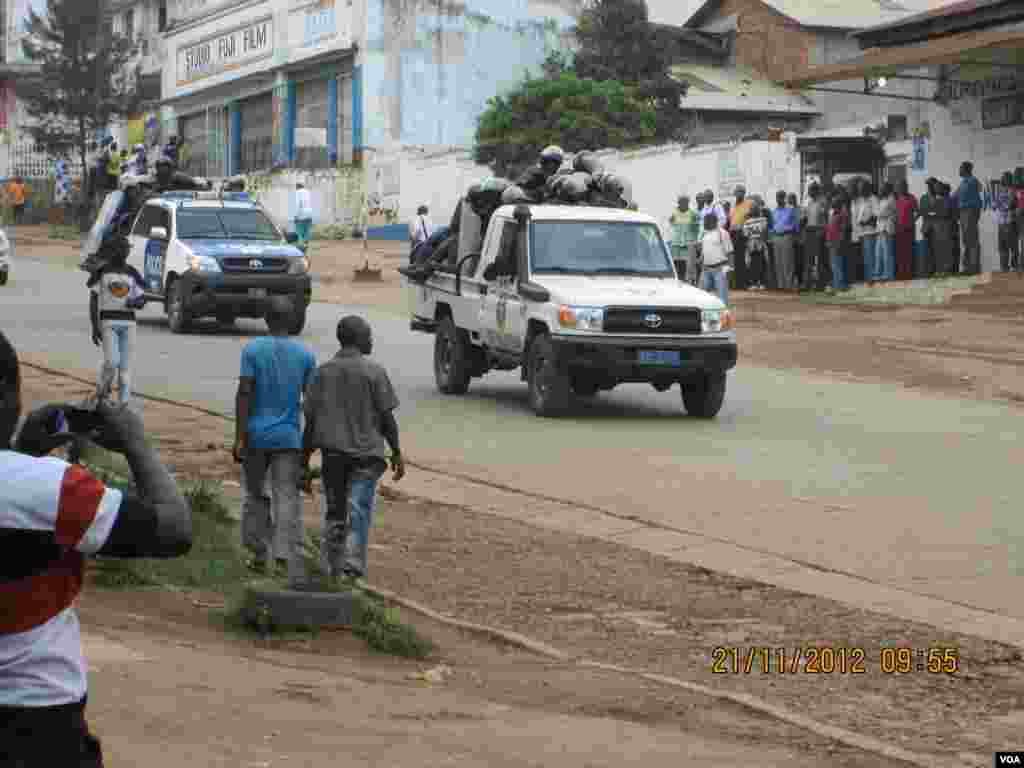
[530, 221, 675, 278]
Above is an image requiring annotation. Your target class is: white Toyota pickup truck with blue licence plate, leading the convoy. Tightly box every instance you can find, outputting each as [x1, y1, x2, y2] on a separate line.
[403, 205, 736, 419]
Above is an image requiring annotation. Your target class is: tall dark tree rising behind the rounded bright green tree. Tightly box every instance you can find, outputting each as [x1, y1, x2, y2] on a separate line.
[573, 0, 686, 139]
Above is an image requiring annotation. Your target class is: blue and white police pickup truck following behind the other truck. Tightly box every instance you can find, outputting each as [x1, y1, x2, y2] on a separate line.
[128, 191, 312, 334]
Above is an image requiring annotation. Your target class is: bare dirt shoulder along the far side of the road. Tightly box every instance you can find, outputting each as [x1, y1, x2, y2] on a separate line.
[15, 227, 1024, 406]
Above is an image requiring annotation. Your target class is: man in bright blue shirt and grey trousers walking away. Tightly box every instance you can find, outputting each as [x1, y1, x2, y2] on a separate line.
[233, 296, 316, 586]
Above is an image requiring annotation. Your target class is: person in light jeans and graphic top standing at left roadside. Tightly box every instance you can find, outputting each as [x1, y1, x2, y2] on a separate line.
[86, 238, 145, 406]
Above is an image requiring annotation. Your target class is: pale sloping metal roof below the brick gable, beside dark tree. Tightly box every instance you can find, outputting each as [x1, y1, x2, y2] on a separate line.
[672, 65, 821, 115]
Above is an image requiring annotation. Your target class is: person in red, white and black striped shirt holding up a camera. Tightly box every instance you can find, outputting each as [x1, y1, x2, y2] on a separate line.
[0, 332, 193, 768]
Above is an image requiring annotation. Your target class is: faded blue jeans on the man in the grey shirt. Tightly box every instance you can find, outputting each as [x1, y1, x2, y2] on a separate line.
[324, 451, 387, 578]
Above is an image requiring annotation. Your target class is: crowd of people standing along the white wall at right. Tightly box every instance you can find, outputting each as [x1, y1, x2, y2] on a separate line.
[669, 163, 1024, 301]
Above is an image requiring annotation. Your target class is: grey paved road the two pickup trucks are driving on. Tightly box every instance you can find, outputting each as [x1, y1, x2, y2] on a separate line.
[8, 248, 1024, 617]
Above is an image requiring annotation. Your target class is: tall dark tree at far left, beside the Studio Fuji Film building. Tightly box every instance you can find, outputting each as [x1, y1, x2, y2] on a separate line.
[15, 0, 139, 222]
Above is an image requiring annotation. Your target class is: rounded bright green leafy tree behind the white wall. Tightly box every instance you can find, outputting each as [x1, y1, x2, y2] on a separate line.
[474, 69, 656, 176]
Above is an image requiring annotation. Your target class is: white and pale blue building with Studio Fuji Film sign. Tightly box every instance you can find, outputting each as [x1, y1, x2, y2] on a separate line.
[160, 0, 575, 228]
